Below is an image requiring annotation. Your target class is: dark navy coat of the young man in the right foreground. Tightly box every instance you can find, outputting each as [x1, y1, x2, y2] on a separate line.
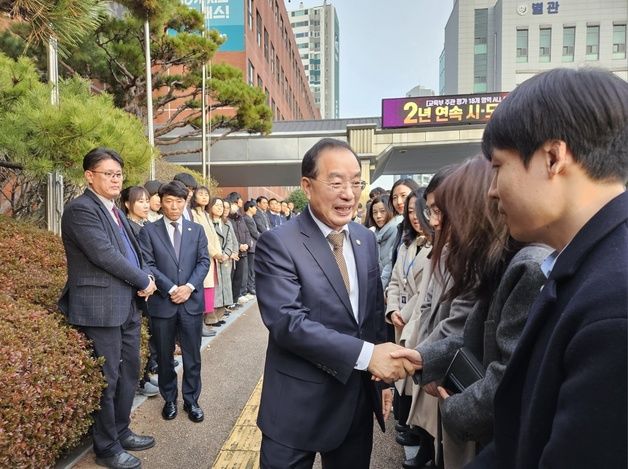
[470, 192, 628, 469]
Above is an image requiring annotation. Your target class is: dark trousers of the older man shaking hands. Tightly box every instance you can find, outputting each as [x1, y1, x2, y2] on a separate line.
[260, 380, 373, 469]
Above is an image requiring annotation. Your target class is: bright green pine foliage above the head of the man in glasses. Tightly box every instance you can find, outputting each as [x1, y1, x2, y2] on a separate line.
[0, 51, 151, 184]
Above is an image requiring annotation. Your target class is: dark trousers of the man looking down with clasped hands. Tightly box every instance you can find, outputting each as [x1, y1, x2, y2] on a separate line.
[152, 306, 203, 404]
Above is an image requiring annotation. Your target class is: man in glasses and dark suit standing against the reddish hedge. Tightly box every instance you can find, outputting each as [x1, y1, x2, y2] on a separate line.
[59, 148, 155, 469]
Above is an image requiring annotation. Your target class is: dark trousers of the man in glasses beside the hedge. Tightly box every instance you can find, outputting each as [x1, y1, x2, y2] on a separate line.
[79, 304, 141, 458]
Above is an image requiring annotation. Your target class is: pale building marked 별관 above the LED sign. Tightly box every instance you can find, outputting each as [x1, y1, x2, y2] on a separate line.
[439, 0, 628, 94]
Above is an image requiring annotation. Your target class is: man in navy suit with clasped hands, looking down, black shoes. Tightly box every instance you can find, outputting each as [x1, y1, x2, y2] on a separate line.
[140, 181, 209, 422]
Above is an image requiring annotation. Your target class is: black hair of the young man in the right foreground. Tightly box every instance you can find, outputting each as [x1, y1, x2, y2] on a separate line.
[482, 68, 628, 183]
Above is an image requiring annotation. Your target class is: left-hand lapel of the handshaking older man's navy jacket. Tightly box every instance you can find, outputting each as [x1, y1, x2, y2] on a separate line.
[299, 210, 355, 322]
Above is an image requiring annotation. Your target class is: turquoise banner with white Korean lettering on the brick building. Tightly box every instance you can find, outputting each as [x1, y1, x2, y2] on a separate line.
[181, 0, 244, 52]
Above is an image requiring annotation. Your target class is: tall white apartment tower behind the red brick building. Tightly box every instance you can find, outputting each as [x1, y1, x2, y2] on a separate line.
[290, 1, 340, 119]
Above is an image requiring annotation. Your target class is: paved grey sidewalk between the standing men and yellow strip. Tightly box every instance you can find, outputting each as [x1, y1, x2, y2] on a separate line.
[55, 301, 267, 469]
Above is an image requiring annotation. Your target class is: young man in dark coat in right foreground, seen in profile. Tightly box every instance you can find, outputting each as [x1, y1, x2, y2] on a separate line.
[464, 69, 628, 469]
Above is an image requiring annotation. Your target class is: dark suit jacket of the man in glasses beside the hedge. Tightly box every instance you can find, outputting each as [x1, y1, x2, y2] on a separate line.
[59, 189, 149, 327]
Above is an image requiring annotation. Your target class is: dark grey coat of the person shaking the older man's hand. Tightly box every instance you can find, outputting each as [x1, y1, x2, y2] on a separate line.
[417, 245, 550, 444]
